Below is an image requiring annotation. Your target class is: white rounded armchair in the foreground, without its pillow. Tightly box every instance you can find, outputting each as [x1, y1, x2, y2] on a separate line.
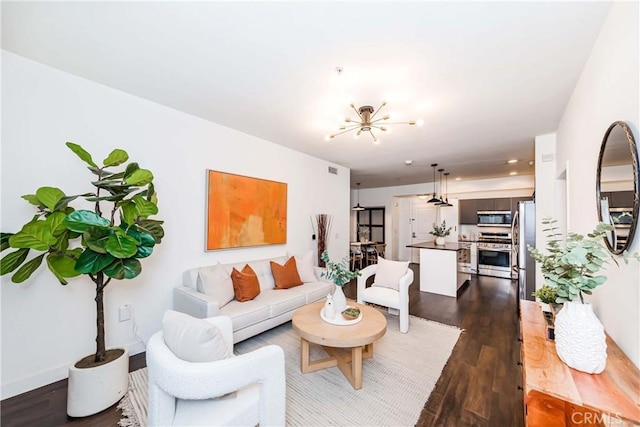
[147, 316, 286, 426]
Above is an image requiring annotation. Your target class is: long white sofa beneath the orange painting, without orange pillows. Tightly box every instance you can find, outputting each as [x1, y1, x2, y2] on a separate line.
[173, 256, 335, 343]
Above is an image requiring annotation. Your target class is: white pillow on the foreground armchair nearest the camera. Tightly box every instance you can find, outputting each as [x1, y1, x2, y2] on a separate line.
[162, 310, 229, 363]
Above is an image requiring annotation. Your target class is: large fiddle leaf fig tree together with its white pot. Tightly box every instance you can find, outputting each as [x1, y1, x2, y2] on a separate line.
[0, 142, 164, 417]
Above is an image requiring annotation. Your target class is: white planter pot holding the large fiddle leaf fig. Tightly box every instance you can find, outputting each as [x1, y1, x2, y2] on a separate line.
[67, 349, 129, 417]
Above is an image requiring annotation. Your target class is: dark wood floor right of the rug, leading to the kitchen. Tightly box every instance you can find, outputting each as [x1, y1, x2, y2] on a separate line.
[345, 264, 524, 427]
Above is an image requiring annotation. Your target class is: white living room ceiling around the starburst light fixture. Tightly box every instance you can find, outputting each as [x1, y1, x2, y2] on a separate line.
[2, 1, 610, 188]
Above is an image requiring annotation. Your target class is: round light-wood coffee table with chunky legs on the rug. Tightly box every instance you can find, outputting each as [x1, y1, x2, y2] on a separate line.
[291, 301, 387, 390]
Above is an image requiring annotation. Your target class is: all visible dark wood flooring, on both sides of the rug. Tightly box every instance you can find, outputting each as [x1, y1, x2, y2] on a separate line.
[0, 265, 524, 427]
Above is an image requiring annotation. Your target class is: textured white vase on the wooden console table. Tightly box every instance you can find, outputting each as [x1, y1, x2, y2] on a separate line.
[554, 301, 607, 374]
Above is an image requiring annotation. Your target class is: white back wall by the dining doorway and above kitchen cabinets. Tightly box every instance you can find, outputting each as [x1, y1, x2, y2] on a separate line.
[349, 175, 534, 260]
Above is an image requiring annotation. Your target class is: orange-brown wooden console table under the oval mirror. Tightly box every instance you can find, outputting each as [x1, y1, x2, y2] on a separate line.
[520, 301, 640, 427]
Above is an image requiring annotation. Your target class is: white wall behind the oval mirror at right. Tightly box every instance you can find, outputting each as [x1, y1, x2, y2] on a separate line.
[557, 2, 640, 367]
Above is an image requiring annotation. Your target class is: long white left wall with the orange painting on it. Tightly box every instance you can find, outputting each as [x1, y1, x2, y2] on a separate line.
[1, 52, 350, 399]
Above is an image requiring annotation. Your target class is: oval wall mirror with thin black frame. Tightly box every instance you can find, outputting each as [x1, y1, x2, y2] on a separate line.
[596, 122, 638, 254]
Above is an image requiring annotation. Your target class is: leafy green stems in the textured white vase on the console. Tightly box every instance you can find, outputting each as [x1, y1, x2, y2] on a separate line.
[527, 218, 618, 304]
